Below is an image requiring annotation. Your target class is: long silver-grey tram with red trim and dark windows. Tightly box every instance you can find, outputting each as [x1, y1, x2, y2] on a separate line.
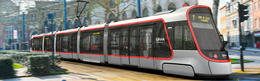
[31, 5, 232, 77]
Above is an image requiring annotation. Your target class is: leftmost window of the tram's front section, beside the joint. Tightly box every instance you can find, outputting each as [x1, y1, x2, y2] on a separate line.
[108, 29, 120, 55]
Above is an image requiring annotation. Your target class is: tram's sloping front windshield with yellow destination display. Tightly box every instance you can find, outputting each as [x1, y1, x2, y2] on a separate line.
[189, 7, 222, 50]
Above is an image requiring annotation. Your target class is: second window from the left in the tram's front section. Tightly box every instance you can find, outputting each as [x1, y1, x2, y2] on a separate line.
[120, 29, 129, 55]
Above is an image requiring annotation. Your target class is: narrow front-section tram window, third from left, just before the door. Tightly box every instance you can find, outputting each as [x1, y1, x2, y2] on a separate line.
[129, 27, 140, 56]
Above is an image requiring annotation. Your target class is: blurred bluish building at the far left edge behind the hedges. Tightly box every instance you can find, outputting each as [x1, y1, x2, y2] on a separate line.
[0, 0, 19, 50]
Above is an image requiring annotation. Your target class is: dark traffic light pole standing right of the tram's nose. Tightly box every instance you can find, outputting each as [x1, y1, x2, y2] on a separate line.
[238, 2, 249, 71]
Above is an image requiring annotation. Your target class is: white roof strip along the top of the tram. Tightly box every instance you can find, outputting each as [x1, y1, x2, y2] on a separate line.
[32, 6, 195, 38]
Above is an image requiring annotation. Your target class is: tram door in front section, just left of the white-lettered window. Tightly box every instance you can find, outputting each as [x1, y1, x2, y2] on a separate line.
[139, 25, 154, 69]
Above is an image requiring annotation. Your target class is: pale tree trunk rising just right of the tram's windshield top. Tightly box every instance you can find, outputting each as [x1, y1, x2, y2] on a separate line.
[212, 0, 219, 25]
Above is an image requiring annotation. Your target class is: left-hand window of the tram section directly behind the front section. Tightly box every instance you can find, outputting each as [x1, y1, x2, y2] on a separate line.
[80, 31, 90, 53]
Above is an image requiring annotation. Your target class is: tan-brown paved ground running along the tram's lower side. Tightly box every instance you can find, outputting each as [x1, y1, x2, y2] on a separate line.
[60, 61, 195, 81]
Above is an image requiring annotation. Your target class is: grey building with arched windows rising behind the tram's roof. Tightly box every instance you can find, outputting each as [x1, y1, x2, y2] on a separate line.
[22, 0, 198, 50]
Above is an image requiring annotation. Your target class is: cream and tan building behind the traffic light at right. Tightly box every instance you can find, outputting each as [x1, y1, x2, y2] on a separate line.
[219, 0, 257, 48]
